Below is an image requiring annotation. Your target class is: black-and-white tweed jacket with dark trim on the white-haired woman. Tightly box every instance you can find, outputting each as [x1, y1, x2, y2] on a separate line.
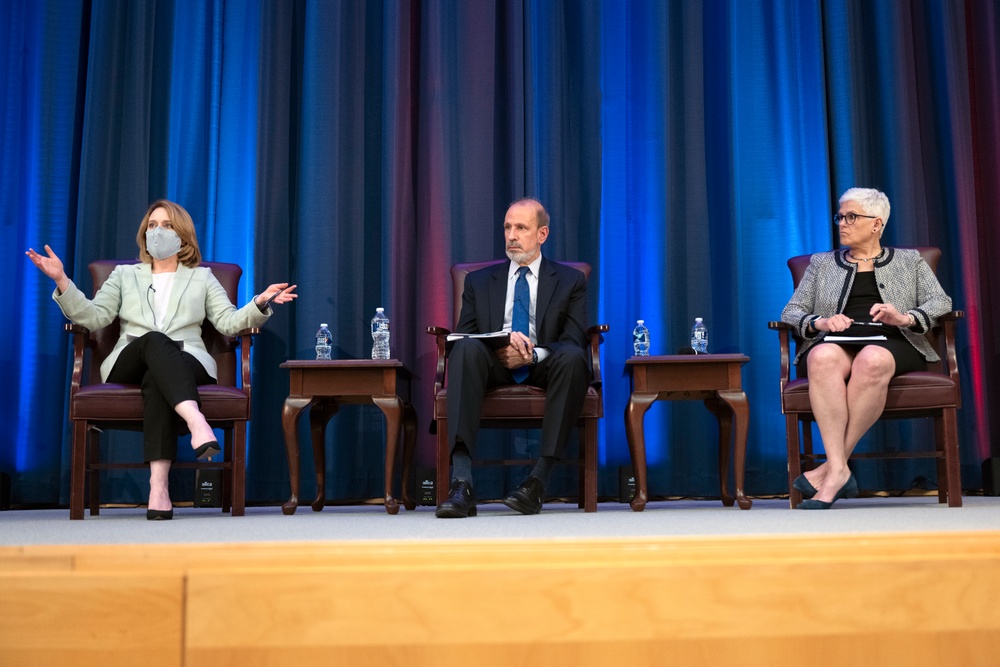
[781, 248, 951, 363]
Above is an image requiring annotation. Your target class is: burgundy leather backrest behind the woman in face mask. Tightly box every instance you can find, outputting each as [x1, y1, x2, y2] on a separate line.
[88, 259, 243, 387]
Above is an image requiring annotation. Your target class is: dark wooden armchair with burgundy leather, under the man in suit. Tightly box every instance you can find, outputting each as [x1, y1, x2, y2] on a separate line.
[427, 260, 608, 512]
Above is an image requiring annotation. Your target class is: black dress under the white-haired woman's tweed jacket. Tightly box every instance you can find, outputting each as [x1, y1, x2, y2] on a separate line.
[795, 271, 927, 378]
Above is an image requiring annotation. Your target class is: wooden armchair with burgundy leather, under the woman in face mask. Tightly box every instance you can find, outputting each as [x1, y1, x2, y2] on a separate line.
[65, 260, 258, 519]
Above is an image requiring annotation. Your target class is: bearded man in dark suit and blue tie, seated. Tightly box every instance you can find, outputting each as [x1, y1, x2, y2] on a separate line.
[436, 199, 591, 518]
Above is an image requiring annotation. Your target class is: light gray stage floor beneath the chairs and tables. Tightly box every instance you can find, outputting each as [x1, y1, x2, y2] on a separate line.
[0, 496, 1000, 546]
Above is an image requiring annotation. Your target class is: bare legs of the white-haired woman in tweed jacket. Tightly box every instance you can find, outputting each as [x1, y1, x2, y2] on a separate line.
[805, 344, 896, 502]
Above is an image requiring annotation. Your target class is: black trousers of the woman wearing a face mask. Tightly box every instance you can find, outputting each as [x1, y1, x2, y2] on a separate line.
[107, 331, 215, 461]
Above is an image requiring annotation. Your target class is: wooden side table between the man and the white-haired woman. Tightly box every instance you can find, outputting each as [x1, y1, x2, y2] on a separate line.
[625, 354, 752, 512]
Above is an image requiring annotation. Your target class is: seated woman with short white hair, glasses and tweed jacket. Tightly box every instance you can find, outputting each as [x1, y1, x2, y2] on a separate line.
[781, 188, 951, 509]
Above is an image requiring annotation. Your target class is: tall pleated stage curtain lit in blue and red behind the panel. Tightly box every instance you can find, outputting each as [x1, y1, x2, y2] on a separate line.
[0, 0, 1000, 505]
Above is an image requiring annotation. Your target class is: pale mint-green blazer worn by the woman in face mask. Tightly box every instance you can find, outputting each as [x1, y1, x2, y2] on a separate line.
[52, 264, 272, 382]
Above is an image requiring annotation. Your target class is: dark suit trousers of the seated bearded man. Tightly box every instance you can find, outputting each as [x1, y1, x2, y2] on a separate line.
[448, 338, 590, 458]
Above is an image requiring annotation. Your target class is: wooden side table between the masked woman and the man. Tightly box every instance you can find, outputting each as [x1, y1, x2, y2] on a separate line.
[281, 359, 417, 514]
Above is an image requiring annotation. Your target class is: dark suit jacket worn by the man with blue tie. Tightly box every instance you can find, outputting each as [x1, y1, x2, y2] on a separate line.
[456, 256, 587, 358]
